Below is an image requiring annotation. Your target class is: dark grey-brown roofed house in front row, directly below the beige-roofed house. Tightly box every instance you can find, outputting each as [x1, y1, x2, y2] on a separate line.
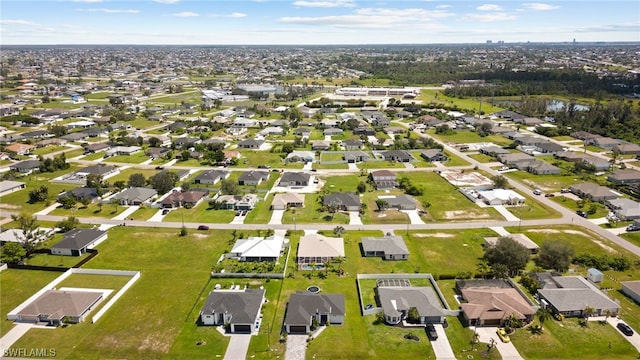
[284, 291, 346, 334]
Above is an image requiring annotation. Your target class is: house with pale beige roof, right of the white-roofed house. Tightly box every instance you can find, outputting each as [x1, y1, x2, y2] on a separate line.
[297, 233, 345, 270]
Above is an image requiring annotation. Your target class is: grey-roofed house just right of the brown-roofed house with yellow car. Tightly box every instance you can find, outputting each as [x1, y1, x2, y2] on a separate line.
[537, 276, 620, 317]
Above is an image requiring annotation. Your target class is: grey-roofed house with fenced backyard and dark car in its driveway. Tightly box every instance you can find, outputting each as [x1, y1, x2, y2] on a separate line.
[377, 286, 446, 325]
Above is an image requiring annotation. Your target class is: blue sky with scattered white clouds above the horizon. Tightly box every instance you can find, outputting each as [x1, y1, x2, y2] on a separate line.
[0, 0, 640, 45]
